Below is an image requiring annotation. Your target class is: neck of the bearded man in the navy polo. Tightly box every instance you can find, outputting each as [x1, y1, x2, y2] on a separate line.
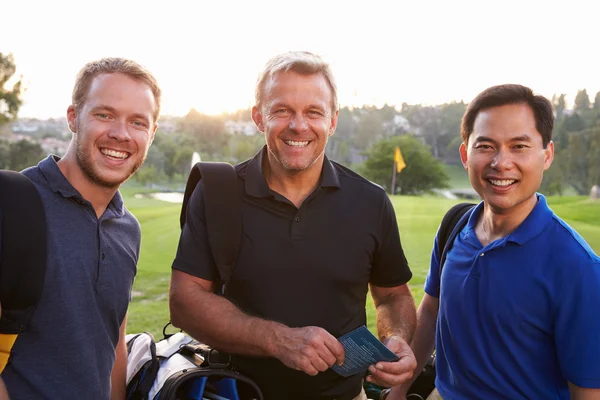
[58, 152, 119, 219]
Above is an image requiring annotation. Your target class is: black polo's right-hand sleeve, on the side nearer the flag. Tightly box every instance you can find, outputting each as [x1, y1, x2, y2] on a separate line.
[370, 194, 412, 287]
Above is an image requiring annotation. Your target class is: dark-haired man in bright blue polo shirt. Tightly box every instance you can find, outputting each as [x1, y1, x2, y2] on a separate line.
[390, 85, 600, 400]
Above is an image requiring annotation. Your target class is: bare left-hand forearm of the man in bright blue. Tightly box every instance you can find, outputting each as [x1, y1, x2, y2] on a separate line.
[387, 293, 440, 400]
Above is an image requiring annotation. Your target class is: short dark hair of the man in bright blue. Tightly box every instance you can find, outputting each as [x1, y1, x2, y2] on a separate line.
[460, 84, 554, 148]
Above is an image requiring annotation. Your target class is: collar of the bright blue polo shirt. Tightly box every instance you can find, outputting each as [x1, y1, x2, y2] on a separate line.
[467, 193, 554, 245]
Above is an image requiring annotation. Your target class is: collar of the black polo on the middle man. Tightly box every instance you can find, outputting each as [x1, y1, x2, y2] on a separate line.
[245, 145, 340, 197]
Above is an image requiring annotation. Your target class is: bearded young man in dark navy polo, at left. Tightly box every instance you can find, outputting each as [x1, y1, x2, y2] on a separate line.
[2, 58, 161, 400]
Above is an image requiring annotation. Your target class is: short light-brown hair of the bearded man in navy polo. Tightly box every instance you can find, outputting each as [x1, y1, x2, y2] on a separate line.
[71, 57, 161, 122]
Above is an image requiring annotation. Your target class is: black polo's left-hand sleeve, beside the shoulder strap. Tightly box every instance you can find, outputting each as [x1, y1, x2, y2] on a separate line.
[172, 181, 217, 281]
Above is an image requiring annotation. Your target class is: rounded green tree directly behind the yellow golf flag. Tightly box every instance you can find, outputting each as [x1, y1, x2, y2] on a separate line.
[359, 135, 450, 194]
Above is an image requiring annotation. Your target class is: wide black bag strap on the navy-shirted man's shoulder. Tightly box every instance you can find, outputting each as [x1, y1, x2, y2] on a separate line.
[0, 170, 47, 334]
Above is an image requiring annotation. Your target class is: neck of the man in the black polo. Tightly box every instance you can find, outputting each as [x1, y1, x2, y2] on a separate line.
[263, 155, 324, 208]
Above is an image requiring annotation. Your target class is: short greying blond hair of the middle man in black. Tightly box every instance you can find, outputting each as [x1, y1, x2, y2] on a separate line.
[255, 51, 339, 112]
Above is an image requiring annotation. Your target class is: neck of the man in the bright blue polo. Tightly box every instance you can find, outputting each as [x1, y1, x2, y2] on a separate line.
[475, 194, 537, 246]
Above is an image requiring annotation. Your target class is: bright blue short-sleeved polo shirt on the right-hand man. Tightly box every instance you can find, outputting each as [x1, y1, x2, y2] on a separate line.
[425, 194, 600, 399]
